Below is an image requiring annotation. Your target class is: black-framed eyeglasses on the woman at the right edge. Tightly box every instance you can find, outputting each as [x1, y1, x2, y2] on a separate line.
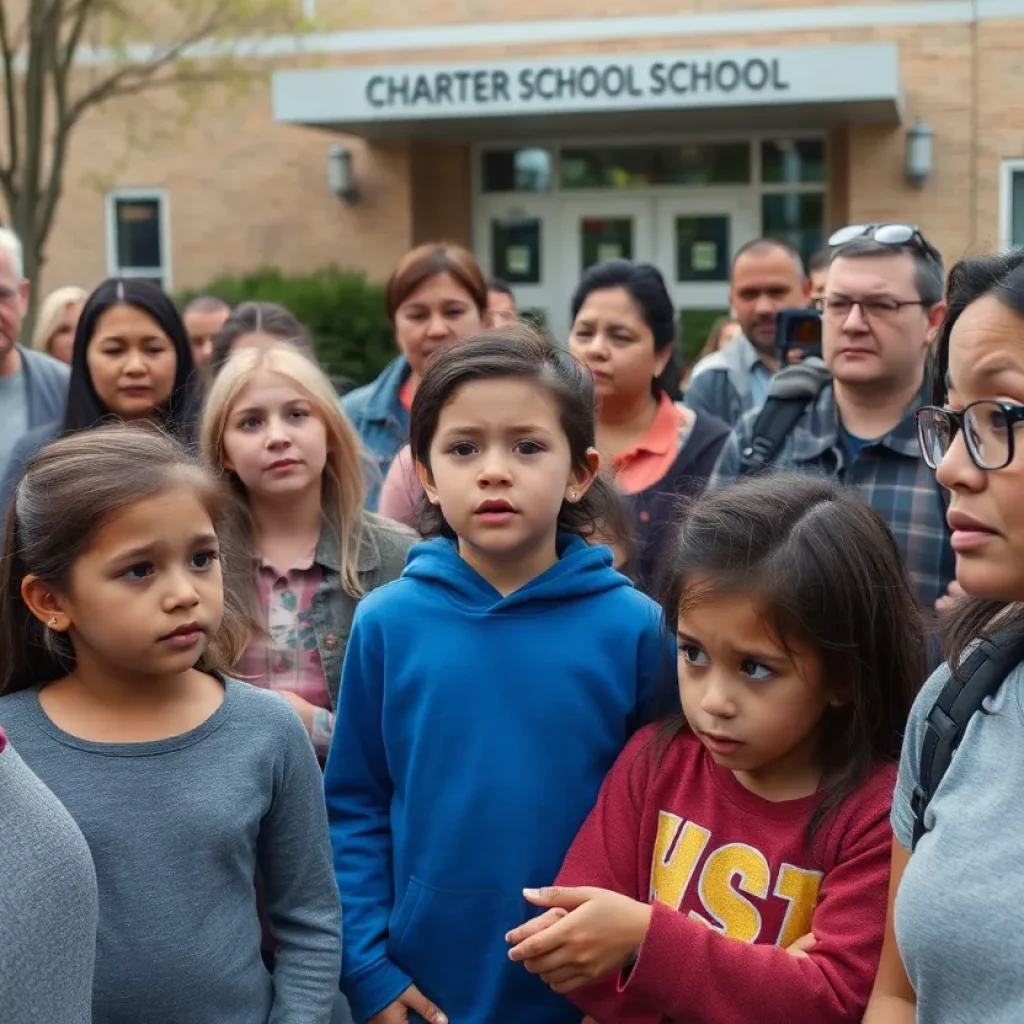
[916, 398, 1024, 470]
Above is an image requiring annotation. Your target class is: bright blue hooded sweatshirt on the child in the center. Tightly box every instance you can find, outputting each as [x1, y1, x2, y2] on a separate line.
[324, 536, 674, 1024]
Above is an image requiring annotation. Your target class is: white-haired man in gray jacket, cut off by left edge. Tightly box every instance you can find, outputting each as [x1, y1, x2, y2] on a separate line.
[0, 227, 70, 478]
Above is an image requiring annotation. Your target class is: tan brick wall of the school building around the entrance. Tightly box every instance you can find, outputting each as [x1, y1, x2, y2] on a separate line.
[19, 7, 1024, 290]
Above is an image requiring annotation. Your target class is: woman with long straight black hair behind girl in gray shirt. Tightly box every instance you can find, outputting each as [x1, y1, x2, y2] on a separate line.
[0, 278, 201, 509]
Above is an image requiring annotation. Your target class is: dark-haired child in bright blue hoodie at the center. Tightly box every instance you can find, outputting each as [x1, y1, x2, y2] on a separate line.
[325, 327, 675, 1024]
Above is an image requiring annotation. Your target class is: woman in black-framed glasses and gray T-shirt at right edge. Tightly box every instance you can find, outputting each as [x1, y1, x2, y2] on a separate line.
[864, 245, 1024, 1024]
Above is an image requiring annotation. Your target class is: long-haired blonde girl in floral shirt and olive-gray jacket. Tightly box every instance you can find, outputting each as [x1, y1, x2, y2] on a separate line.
[202, 346, 416, 757]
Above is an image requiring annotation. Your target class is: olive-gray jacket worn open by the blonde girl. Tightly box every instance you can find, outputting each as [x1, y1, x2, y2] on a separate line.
[312, 512, 419, 710]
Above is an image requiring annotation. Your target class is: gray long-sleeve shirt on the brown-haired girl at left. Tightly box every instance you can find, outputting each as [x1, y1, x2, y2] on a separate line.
[0, 681, 341, 1024]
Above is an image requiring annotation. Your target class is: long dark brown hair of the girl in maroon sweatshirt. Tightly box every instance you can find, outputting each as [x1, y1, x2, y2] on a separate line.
[660, 473, 927, 839]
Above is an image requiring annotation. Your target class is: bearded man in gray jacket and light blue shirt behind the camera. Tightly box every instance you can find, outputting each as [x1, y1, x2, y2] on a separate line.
[685, 239, 810, 427]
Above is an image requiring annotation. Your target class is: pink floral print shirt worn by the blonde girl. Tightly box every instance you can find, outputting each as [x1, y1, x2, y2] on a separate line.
[238, 553, 334, 757]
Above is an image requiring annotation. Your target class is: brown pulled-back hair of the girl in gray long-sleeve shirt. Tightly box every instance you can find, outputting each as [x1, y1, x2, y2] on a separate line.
[0, 426, 251, 693]
